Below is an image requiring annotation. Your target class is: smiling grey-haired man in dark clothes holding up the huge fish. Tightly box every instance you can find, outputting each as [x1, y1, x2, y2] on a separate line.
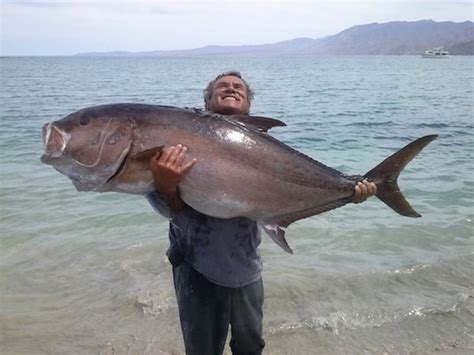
[148, 72, 376, 355]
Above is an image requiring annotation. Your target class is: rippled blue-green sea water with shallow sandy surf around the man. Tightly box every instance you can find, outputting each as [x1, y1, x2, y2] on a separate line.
[0, 56, 474, 354]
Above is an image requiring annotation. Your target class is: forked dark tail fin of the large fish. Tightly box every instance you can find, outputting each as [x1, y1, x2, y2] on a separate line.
[364, 134, 438, 217]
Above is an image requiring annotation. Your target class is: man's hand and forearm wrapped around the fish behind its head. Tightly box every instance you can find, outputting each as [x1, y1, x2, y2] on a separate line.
[150, 144, 196, 213]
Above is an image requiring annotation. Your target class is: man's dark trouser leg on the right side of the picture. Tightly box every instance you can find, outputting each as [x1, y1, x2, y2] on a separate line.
[230, 279, 265, 355]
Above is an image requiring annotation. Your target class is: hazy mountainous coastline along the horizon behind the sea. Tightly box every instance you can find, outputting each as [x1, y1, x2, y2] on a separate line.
[74, 20, 474, 57]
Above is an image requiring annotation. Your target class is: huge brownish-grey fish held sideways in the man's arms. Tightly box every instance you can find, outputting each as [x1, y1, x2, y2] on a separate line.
[41, 104, 437, 253]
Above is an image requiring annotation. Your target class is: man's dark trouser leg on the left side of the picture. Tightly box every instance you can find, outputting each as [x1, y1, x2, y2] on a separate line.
[173, 262, 231, 355]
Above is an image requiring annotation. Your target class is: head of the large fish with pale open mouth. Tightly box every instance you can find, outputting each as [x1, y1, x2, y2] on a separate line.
[41, 107, 133, 191]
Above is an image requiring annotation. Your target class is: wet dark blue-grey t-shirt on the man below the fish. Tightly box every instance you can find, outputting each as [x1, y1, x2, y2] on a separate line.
[147, 193, 262, 287]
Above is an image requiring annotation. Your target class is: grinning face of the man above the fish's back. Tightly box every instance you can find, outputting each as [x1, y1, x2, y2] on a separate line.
[206, 75, 250, 115]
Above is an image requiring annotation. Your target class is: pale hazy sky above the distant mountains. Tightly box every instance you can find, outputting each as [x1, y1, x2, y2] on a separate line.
[0, 0, 474, 56]
